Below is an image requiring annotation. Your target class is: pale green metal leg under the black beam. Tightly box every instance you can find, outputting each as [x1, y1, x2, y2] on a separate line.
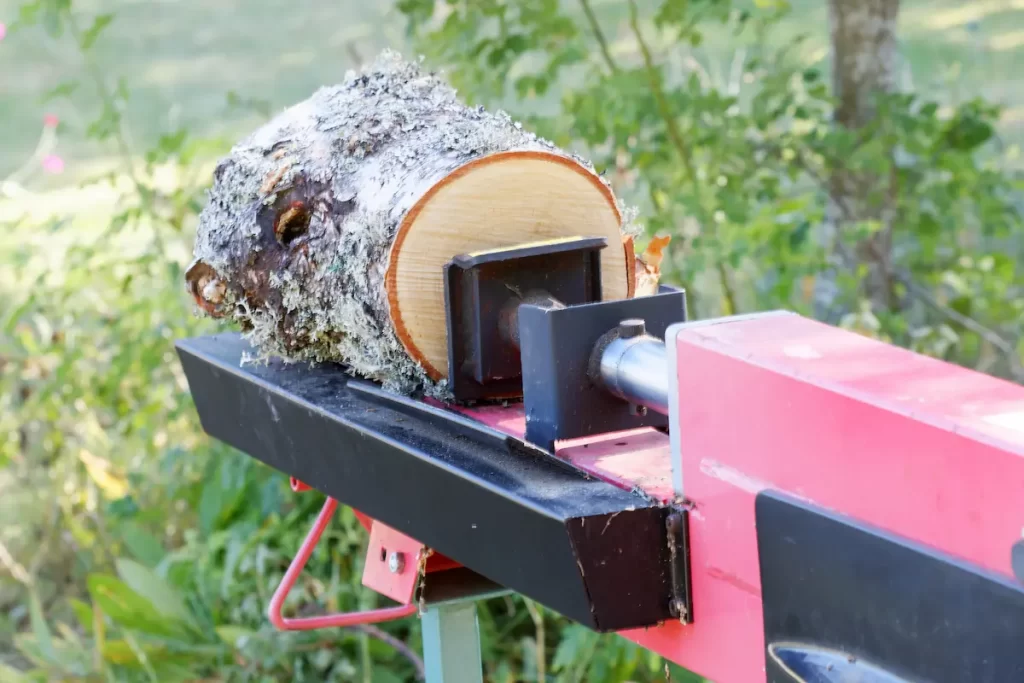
[422, 601, 483, 683]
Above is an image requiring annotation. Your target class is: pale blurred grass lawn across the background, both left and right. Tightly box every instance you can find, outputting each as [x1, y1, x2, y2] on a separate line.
[0, 0, 1024, 187]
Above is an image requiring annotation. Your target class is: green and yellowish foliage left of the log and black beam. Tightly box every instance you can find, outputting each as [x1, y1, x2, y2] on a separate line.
[0, 0, 417, 682]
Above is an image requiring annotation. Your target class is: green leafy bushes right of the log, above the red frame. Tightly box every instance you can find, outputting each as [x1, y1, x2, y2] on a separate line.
[400, 0, 1024, 379]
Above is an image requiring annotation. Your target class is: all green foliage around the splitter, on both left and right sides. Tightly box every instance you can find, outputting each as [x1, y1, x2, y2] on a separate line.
[0, 0, 1024, 681]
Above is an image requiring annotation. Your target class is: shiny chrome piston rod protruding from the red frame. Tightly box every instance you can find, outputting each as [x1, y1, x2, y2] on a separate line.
[591, 319, 669, 415]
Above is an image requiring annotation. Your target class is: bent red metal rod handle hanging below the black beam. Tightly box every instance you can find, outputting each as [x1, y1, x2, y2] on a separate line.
[267, 497, 417, 631]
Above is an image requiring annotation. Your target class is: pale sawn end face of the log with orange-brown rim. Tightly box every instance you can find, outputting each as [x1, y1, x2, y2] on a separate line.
[385, 152, 633, 381]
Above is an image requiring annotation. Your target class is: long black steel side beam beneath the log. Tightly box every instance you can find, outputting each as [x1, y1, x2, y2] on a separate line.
[177, 334, 672, 631]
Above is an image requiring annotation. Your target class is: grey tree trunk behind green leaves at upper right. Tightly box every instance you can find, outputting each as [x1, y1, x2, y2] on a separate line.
[825, 0, 899, 307]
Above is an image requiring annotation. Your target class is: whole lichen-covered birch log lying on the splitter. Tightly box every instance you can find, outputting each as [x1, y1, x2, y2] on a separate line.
[185, 51, 635, 398]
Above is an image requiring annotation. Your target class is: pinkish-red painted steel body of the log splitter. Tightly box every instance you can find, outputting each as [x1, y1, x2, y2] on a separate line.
[469, 314, 1024, 683]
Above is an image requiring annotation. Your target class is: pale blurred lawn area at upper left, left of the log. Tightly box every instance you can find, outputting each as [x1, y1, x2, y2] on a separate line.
[0, 0, 402, 181]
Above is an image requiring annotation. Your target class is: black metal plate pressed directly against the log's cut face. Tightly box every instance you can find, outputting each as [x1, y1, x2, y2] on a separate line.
[444, 238, 608, 401]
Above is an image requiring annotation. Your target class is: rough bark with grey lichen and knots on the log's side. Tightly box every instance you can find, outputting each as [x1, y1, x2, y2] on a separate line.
[186, 51, 626, 396]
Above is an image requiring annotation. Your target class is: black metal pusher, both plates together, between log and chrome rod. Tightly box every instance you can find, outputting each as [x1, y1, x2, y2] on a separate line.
[444, 238, 686, 451]
